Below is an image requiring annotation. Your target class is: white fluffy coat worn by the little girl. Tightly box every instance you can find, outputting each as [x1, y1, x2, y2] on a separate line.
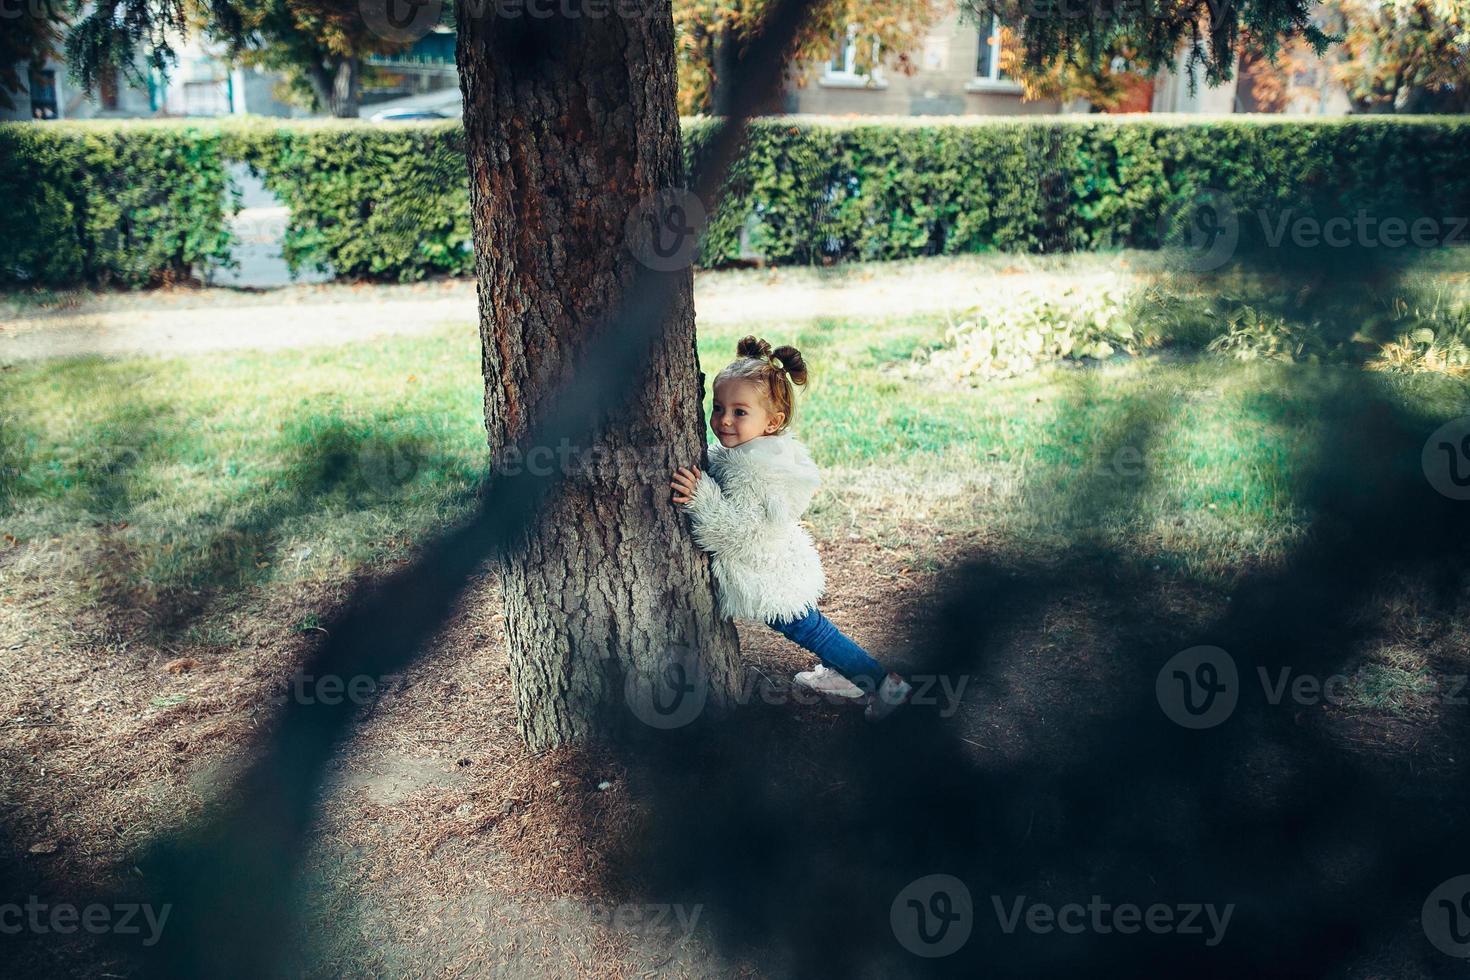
[686, 432, 826, 621]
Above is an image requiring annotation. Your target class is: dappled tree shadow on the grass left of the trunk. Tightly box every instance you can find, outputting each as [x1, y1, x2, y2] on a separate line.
[0, 359, 479, 639]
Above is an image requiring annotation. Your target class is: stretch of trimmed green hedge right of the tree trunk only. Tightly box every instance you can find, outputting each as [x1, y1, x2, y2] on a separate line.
[688, 116, 1470, 264]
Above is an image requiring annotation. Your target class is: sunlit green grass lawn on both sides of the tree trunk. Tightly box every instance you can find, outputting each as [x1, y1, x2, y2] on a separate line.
[0, 256, 1467, 620]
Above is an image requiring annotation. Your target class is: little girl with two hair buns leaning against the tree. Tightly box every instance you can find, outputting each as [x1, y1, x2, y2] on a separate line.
[670, 336, 911, 721]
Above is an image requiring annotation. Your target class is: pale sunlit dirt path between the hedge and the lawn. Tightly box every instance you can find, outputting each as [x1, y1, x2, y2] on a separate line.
[0, 257, 1113, 363]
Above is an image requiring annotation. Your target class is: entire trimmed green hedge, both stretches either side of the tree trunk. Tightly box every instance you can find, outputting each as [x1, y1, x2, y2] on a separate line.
[0, 116, 1470, 285]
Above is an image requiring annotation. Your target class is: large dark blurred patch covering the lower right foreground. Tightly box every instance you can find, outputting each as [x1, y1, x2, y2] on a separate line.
[596, 364, 1470, 977]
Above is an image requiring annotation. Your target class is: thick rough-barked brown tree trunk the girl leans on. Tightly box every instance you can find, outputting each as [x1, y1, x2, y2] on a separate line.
[459, 0, 738, 749]
